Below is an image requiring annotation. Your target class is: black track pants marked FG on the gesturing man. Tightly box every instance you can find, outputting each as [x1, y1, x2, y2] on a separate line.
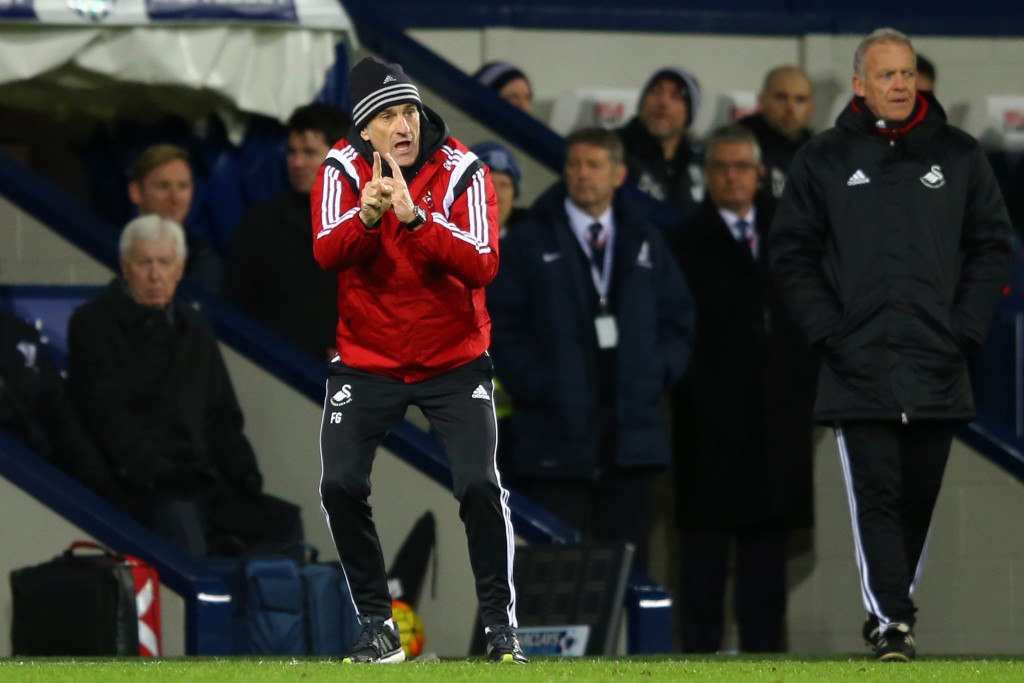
[321, 355, 516, 627]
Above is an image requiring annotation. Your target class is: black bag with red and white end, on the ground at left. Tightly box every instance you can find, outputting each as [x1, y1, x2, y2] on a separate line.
[10, 542, 160, 656]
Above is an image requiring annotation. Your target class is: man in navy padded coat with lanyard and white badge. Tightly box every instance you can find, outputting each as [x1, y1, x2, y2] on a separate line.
[487, 128, 693, 567]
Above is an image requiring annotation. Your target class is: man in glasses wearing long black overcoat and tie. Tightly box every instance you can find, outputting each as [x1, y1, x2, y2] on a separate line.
[673, 124, 814, 652]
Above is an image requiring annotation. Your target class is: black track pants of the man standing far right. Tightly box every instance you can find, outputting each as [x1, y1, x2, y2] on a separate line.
[836, 421, 956, 627]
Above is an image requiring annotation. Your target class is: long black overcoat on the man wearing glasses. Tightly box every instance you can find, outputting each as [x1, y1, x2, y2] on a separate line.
[673, 199, 815, 530]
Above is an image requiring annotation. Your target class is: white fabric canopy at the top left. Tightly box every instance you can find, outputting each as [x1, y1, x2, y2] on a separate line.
[0, 0, 356, 132]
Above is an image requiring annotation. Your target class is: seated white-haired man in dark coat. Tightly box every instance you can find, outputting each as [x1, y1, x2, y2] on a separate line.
[68, 214, 302, 555]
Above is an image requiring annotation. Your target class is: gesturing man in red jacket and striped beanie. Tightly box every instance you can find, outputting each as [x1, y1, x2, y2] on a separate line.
[311, 57, 526, 664]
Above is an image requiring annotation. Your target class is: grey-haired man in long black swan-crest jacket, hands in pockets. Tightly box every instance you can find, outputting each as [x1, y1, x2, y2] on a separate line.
[769, 29, 1013, 661]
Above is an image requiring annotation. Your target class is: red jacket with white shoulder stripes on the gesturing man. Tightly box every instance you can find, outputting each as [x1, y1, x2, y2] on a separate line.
[310, 113, 498, 382]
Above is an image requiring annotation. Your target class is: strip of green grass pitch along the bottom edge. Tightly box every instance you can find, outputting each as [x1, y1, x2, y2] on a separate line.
[0, 655, 1024, 683]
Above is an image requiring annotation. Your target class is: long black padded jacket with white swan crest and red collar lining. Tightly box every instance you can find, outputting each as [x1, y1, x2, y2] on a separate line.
[769, 94, 1013, 422]
